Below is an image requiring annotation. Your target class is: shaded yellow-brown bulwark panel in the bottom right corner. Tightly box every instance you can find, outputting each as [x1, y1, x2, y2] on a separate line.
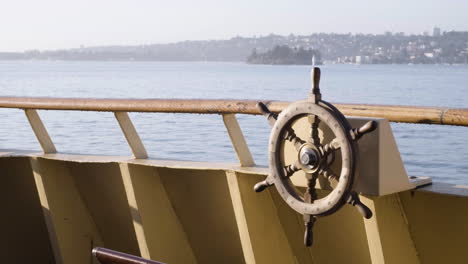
[399, 191, 468, 264]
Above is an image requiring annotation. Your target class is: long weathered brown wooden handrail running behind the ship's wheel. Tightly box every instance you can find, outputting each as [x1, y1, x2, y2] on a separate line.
[0, 97, 468, 126]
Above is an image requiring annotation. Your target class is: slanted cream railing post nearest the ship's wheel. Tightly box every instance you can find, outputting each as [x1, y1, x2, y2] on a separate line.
[223, 114, 255, 167]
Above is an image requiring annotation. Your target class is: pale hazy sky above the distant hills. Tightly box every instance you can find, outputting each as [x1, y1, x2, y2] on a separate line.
[0, 0, 468, 51]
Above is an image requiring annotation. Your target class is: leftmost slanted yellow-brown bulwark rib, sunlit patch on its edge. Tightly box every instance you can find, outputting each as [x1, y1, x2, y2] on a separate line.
[30, 158, 103, 264]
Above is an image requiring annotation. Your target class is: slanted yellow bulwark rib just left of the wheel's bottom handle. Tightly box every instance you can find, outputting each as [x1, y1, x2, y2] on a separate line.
[226, 171, 301, 264]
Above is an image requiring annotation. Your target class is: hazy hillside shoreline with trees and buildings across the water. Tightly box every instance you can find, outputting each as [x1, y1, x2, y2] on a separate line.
[0, 30, 468, 65]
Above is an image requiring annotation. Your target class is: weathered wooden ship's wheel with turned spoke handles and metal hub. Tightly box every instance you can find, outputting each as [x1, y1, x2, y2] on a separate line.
[254, 67, 377, 246]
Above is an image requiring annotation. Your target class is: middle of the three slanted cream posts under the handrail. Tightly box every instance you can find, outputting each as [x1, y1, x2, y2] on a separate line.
[114, 112, 148, 159]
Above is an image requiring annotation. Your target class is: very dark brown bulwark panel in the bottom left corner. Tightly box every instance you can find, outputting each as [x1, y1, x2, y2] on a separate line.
[0, 158, 55, 263]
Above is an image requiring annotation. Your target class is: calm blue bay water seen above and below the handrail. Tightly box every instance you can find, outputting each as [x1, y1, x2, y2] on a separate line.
[0, 61, 468, 184]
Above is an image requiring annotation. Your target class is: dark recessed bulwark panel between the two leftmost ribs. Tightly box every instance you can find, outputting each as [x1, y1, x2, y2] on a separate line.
[68, 163, 140, 255]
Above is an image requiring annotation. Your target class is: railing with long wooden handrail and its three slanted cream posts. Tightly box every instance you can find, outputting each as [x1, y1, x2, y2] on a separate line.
[0, 97, 468, 166]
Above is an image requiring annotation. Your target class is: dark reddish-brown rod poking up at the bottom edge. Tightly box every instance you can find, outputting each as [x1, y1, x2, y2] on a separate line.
[92, 247, 164, 264]
